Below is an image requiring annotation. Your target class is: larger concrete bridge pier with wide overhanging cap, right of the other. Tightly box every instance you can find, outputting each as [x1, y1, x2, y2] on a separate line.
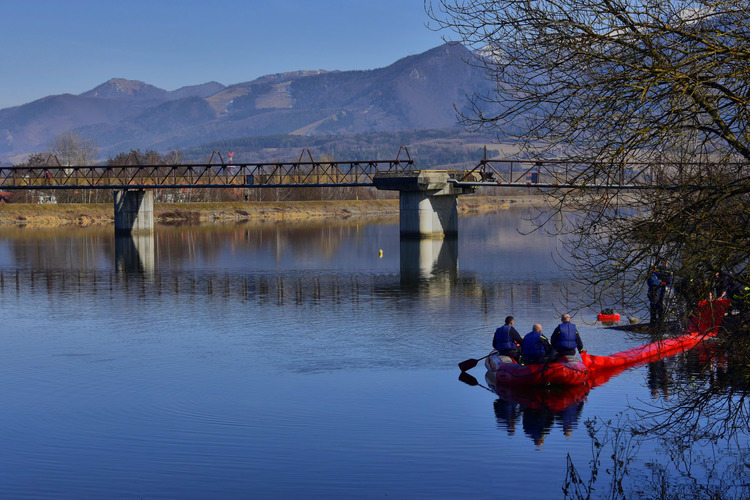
[373, 170, 474, 238]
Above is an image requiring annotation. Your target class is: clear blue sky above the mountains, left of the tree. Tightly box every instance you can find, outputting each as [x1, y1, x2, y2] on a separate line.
[0, 0, 450, 108]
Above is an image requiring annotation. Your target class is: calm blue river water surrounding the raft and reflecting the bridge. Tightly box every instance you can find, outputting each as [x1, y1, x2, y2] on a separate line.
[0, 209, 748, 499]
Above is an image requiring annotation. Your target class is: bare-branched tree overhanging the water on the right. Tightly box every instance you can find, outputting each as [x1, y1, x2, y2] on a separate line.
[425, 0, 750, 328]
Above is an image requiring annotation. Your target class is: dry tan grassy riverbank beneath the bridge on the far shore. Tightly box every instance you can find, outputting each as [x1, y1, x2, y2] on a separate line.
[0, 196, 545, 227]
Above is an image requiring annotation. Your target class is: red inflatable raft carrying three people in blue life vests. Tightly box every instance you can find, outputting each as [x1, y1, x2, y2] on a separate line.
[484, 352, 589, 386]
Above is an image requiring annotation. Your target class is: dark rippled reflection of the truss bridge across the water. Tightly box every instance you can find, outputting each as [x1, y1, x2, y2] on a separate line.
[0, 248, 561, 315]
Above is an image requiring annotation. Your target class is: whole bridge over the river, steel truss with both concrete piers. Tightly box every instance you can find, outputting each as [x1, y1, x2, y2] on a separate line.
[0, 147, 664, 237]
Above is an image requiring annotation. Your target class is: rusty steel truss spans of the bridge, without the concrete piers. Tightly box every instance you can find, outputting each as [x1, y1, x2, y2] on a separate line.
[0, 147, 682, 190]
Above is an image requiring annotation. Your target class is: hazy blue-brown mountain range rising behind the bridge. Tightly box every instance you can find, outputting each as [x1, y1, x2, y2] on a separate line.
[0, 44, 506, 165]
